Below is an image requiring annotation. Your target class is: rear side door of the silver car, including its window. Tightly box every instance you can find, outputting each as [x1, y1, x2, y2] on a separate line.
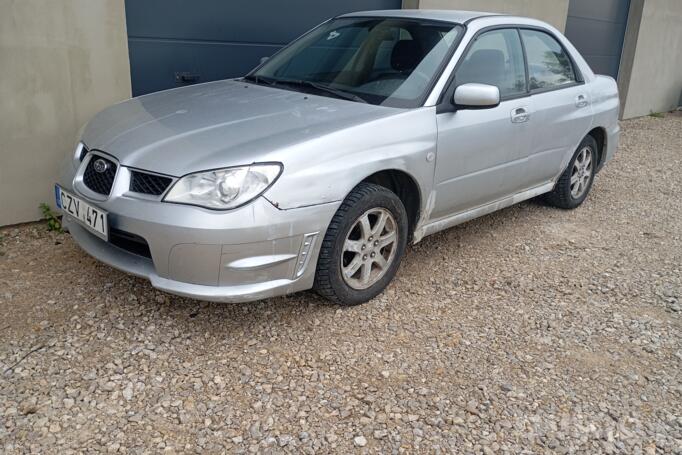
[520, 29, 592, 187]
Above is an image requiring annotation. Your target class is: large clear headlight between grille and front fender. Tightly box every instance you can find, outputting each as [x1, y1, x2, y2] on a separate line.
[164, 163, 282, 210]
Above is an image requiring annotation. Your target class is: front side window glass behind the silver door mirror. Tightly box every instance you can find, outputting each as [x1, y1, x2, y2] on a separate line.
[455, 29, 526, 98]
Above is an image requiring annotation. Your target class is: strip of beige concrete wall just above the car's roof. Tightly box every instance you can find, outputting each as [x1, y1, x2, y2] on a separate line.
[403, 0, 569, 32]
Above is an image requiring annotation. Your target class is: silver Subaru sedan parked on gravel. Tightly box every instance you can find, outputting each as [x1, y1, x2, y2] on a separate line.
[55, 10, 619, 305]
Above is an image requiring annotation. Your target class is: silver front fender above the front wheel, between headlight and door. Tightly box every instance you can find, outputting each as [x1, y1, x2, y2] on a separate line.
[265, 107, 437, 215]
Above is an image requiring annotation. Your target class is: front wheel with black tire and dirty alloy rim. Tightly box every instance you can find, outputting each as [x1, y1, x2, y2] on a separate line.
[313, 183, 408, 305]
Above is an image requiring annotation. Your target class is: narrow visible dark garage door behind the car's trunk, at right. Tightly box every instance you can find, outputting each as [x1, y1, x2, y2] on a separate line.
[566, 0, 630, 78]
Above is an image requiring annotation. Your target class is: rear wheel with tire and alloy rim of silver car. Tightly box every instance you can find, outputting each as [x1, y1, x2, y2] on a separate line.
[544, 136, 599, 210]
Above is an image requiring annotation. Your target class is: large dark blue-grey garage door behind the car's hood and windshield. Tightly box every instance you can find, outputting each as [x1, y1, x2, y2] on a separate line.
[126, 0, 401, 96]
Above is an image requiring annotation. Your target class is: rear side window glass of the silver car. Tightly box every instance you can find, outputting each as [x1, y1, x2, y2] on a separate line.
[521, 30, 576, 90]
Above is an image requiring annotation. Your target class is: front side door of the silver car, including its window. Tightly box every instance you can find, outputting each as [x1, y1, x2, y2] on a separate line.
[430, 28, 534, 220]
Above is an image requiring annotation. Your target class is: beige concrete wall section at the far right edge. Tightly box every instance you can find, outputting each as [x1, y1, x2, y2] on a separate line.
[618, 0, 682, 118]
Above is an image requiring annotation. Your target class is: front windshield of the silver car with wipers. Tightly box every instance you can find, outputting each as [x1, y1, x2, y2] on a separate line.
[246, 17, 462, 107]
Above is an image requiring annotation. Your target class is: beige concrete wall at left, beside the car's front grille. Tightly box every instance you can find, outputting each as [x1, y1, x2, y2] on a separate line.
[0, 0, 130, 226]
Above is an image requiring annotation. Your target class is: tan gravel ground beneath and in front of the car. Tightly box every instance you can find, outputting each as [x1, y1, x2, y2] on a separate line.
[0, 115, 682, 454]
